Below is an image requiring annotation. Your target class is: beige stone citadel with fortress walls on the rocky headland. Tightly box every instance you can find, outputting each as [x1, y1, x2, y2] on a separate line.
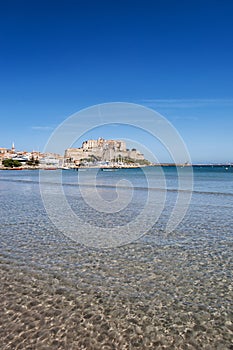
[64, 138, 145, 167]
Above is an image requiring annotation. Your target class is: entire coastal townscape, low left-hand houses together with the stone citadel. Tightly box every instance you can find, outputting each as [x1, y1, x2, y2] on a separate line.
[0, 138, 145, 168]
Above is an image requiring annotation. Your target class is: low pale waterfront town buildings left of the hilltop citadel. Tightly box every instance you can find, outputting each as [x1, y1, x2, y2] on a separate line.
[0, 143, 63, 168]
